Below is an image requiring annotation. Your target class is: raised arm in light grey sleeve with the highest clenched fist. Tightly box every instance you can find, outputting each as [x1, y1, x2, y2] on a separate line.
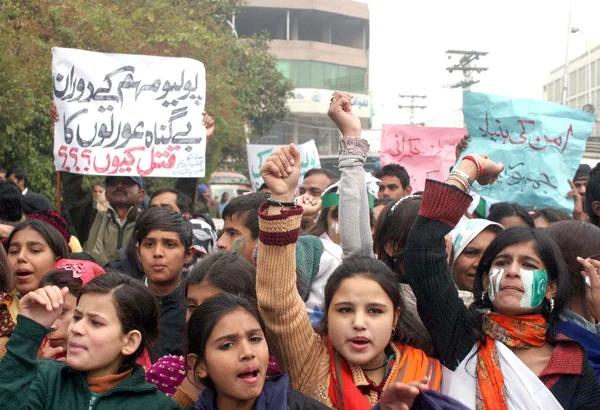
[327, 91, 374, 258]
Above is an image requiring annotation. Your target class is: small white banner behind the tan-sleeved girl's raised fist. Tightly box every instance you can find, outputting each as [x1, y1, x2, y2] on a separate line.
[246, 140, 321, 191]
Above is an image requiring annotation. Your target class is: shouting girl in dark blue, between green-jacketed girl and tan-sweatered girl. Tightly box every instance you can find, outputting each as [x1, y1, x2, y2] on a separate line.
[187, 293, 327, 410]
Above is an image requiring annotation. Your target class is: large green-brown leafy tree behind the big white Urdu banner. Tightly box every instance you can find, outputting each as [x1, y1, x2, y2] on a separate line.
[0, 0, 291, 196]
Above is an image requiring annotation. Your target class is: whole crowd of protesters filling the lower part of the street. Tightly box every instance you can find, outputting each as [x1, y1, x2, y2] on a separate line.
[0, 48, 600, 410]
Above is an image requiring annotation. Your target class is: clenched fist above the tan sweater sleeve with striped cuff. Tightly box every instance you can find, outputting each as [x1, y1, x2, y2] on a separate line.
[260, 144, 300, 202]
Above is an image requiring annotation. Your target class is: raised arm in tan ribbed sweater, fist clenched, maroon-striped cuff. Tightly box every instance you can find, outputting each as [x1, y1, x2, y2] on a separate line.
[256, 145, 329, 394]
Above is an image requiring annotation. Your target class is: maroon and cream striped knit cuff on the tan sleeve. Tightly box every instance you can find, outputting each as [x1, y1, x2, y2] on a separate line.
[258, 203, 303, 246]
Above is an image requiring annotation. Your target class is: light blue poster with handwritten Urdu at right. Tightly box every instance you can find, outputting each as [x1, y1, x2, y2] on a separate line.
[463, 92, 595, 212]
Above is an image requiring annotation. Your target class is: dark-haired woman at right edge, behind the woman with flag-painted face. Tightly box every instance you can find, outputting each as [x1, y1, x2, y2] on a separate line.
[546, 221, 600, 380]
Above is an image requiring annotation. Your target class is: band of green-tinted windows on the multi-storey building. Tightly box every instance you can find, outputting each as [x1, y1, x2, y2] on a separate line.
[277, 60, 367, 94]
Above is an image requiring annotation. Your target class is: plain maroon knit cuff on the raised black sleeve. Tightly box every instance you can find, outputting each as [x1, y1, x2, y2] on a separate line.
[419, 179, 473, 227]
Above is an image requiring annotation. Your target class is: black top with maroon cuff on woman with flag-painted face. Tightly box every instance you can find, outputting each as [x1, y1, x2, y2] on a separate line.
[404, 180, 600, 409]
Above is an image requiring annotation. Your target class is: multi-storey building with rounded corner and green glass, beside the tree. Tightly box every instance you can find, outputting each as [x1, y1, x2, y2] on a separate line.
[233, 0, 371, 155]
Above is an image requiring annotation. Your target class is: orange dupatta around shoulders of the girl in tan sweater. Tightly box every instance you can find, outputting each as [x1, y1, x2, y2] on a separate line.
[324, 336, 442, 410]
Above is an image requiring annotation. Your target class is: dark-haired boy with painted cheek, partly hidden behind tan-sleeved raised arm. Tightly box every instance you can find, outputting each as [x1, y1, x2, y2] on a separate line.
[217, 192, 269, 262]
